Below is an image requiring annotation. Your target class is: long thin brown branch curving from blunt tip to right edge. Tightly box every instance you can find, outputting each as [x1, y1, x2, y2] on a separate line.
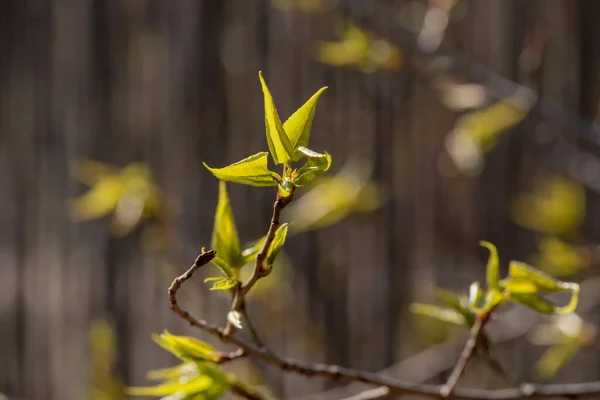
[169, 250, 600, 400]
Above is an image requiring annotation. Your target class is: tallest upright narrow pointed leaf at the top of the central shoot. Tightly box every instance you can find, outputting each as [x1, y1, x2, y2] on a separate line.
[258, 71, 294, 164]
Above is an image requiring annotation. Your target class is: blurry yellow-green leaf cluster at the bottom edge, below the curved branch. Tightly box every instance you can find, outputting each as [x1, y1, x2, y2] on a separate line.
[127, 331, 230, 400]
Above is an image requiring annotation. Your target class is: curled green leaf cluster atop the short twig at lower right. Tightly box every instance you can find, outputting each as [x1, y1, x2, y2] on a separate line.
[411, 241, 579, 326]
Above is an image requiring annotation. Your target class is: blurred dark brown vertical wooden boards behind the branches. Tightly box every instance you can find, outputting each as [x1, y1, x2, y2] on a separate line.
[0, 0, 600, 400]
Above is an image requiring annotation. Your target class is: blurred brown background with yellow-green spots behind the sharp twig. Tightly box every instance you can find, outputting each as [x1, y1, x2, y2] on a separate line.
[0, 0, 600, 400]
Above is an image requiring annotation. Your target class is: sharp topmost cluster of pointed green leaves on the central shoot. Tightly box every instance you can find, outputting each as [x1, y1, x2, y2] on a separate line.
[204, 72, 331, 197]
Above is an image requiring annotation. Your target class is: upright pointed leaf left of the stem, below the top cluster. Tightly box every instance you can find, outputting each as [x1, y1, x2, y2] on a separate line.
[211, 181, 241, 268]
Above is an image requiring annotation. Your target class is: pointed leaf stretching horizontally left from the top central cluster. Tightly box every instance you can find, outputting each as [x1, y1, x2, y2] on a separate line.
[203, 152, 281, 187]
